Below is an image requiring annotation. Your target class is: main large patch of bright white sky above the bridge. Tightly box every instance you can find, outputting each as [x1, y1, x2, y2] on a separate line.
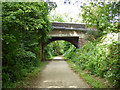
[51, 0, 86, 20]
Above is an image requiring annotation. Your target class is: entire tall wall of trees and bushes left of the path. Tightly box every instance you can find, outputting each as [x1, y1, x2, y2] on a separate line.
[2, 2, 51, 88]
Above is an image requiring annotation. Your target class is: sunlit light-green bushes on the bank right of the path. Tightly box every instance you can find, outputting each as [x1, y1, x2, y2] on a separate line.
[65, 35, 120, 87]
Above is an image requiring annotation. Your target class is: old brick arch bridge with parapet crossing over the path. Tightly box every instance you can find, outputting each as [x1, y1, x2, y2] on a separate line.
[47, 22, 95, 48]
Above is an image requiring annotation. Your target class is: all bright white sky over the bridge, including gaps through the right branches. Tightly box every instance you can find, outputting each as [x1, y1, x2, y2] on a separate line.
[50, 0, 117, 23]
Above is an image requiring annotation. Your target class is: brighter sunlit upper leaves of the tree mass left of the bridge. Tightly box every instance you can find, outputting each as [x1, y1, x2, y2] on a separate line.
[2, 2, 50, 41]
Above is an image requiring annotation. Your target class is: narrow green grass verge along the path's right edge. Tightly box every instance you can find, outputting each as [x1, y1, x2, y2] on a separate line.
[67, 60, 110, 88]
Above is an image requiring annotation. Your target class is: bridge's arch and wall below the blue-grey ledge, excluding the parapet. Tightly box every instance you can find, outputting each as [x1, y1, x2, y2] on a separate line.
[46, 29, 87, 48]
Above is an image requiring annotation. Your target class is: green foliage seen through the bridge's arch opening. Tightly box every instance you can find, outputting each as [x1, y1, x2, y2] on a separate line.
[44, 40, 75, 58]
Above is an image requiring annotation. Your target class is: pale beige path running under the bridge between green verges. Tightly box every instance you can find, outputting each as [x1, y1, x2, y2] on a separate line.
[29, 56, 89, 88]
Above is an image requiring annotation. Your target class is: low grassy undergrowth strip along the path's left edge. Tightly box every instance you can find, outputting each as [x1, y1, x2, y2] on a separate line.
[3, 62, 48, 88]
